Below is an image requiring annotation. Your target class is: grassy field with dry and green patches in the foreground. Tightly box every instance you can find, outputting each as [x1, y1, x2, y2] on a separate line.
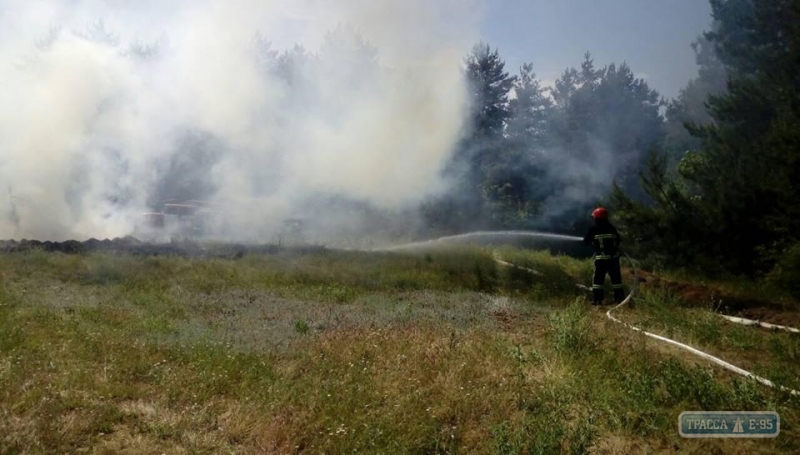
[0, 248, 800, 454]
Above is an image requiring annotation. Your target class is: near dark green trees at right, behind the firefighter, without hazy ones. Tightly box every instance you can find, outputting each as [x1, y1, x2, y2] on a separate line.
[609, 0, 800, 296]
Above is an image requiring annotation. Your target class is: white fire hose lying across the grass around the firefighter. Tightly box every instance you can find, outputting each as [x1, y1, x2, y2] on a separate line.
[495, 254, 800, 396]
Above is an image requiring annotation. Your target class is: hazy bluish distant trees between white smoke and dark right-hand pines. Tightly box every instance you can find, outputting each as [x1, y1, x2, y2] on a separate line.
[422, 42, 665, 239]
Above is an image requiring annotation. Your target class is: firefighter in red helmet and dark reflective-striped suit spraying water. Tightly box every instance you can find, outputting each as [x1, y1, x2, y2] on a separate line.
[583, 207, 625, 305]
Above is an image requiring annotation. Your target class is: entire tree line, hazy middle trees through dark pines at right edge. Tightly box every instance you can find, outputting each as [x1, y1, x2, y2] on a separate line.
[428, 0, 800, 296]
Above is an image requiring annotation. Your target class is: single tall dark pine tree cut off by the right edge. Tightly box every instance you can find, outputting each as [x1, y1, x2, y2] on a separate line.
[689, 0, 800, 273]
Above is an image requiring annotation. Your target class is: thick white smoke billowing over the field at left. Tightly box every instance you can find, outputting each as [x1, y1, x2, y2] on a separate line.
[0, 0, 477, 240]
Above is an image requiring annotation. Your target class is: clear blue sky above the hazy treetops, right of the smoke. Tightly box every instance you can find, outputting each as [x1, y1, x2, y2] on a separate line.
[481, 0, 711, 98]
